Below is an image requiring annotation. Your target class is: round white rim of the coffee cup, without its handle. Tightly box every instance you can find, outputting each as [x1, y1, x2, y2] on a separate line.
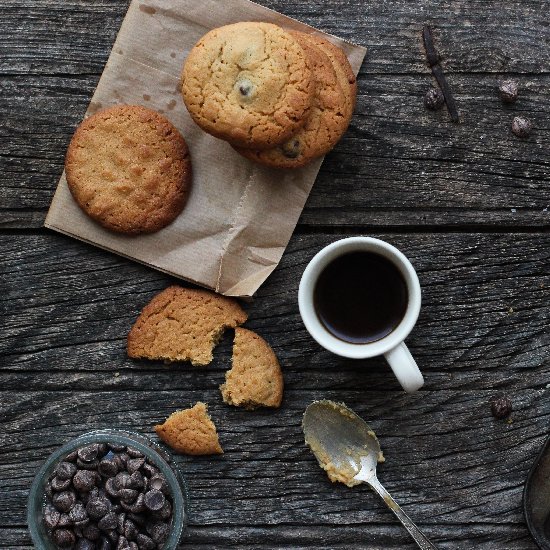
[298, 237, 421, 359]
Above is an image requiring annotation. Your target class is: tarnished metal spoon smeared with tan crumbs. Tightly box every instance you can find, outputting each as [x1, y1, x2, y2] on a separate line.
[302, 401, 436, 550]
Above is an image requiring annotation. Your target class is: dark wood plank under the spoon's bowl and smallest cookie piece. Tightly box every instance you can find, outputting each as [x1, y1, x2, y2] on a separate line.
[0, 387, 550, 544]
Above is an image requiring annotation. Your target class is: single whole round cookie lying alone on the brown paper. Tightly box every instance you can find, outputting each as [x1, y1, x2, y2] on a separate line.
[65, 105, 191, 235]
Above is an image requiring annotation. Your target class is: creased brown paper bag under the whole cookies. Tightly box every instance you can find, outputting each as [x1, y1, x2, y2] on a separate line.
[45, 0, 366, 296]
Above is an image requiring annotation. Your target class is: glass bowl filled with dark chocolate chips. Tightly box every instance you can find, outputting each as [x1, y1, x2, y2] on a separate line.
[27, 430, 188, 550]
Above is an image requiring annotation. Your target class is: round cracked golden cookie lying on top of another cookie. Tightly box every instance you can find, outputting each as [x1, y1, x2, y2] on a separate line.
[182, 22, 314, 149]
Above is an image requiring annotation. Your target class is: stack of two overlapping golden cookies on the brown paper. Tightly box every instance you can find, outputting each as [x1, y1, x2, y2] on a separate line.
[182, 22, 357, 168]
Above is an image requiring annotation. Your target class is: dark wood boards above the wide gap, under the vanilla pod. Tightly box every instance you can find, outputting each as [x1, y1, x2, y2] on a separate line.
[0, 0, 550, 228]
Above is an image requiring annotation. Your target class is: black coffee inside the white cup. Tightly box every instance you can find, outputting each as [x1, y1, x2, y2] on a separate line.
[313, 252, 408, 344]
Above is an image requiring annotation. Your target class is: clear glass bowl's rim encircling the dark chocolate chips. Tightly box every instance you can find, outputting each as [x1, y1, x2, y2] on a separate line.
[27, 430, 189, 550]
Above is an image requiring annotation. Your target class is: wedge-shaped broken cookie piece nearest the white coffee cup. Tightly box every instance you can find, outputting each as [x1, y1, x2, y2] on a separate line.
[220, 328, 284, 409]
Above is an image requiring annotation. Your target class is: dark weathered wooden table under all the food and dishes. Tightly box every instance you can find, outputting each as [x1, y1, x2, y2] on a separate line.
[0, 0, 550, 550]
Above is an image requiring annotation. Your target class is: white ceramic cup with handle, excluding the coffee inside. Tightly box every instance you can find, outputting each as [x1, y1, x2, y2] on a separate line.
[298, 237, 424, 392]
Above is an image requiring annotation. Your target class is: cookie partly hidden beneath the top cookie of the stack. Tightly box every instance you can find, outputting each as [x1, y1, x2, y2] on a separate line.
[236, 31, 352, 168]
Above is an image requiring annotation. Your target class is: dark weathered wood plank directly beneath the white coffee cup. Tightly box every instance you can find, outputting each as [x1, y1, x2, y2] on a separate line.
[0, 233, 550, 391]
